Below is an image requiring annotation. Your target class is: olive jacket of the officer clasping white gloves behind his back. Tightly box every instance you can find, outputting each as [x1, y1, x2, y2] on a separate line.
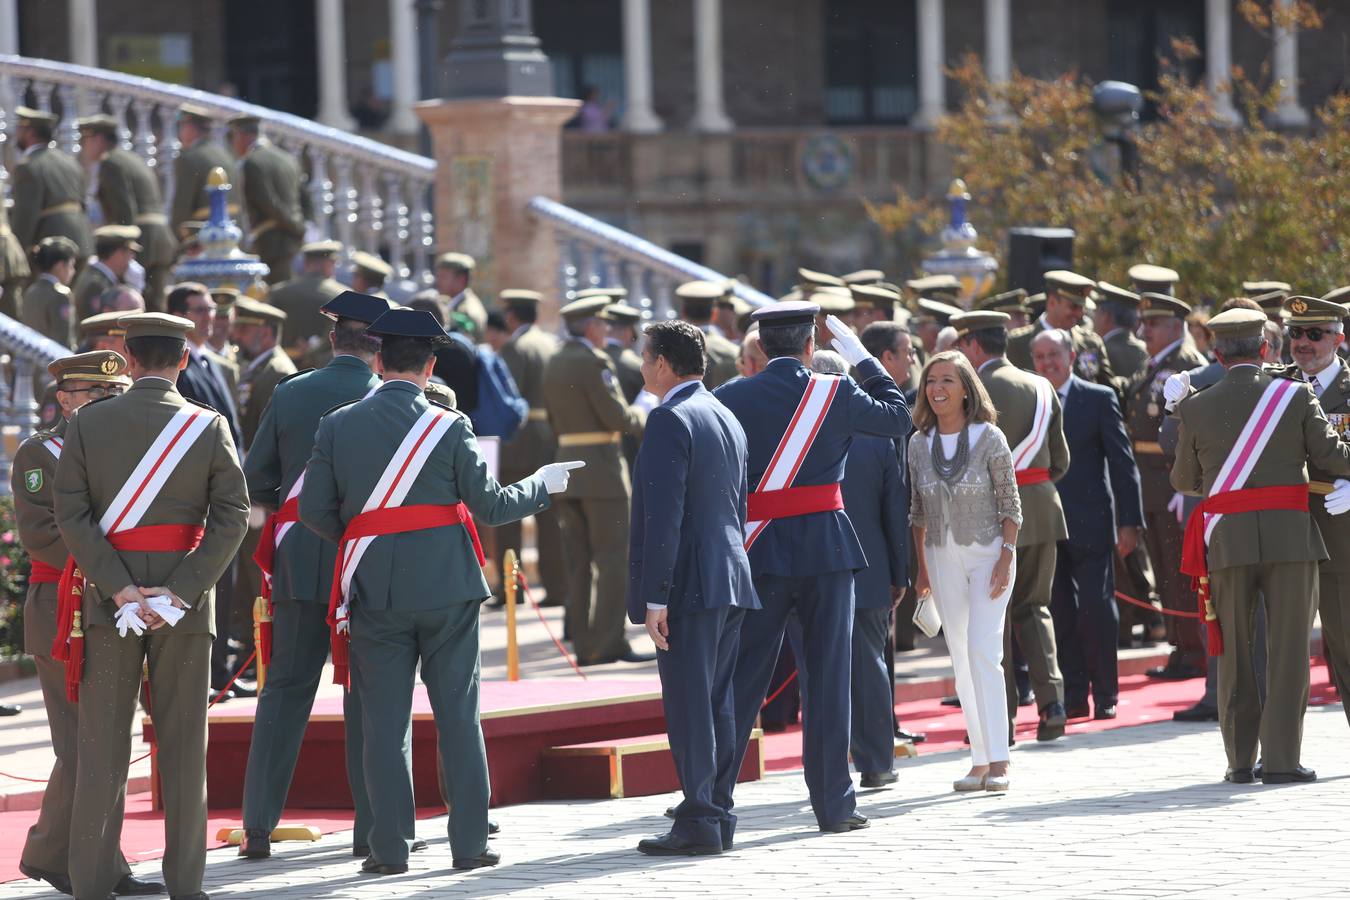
[55, 378, 248, 634]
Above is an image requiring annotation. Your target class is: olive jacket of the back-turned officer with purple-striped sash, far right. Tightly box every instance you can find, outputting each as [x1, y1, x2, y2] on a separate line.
[1172, 366, 1350, 571]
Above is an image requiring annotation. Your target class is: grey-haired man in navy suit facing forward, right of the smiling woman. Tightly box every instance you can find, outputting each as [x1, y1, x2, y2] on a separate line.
[1031, 329, 1143, 719]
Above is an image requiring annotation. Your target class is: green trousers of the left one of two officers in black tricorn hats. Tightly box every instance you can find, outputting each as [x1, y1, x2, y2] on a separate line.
[244, 600, 372, 846]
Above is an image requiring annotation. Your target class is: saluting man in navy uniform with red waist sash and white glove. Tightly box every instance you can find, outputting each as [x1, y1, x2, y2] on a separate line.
[717, 301, 910, 831]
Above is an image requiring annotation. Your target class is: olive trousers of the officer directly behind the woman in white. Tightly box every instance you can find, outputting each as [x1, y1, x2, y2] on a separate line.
[999, 541, 1064, 729]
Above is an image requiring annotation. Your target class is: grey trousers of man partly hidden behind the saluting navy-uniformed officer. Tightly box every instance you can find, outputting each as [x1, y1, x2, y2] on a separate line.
[849, 606, 895, 773]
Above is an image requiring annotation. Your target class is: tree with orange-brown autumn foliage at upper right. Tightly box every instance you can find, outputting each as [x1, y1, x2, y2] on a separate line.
[868, 0, 1350, 304]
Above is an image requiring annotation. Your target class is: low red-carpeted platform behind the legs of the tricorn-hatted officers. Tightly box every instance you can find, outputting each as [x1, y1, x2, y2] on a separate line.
[160, 676, 666, 810]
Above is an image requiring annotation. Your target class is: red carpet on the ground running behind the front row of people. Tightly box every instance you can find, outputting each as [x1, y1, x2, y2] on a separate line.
[0, 660, 1337, 882]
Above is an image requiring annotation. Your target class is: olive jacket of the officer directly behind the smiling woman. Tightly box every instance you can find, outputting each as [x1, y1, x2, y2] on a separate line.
[980, 359, 1069, 546]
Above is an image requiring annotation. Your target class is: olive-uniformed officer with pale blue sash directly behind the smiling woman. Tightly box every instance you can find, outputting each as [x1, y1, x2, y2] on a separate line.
[952, 312, 1069, 741]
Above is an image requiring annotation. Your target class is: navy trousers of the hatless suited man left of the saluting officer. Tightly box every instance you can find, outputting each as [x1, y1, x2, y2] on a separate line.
[656, 606, 743, 846]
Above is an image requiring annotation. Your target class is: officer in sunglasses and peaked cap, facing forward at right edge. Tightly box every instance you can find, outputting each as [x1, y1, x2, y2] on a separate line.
[1284, 287, 1350, 718]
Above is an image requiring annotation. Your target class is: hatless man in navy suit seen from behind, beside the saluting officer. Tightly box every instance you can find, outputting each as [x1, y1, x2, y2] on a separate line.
[628, 321, 759, 855]
